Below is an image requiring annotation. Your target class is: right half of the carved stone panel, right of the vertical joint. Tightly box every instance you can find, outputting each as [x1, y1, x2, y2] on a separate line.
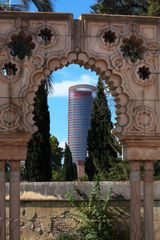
[80, 15, 159, 136]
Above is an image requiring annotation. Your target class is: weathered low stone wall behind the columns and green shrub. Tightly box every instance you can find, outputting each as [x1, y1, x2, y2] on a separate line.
[6, 182, 160, 240]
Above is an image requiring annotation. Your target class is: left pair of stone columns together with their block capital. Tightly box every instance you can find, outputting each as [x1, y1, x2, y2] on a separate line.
[0, 132, 31, 240]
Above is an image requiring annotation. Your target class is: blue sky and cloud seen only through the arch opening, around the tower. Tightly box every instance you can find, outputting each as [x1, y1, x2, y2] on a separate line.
[26, 59, 122, 180]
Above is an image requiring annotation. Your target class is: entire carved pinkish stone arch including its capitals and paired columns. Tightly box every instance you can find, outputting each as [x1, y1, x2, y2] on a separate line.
[0, 12, 160, 240]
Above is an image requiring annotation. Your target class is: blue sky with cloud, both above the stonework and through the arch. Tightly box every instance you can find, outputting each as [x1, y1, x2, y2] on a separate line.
[48, 0, 98, 146]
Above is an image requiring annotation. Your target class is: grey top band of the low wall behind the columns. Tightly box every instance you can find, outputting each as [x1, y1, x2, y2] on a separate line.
[6, 181, 160, 201]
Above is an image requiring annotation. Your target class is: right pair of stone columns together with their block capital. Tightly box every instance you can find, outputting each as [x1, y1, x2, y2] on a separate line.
[123, 137, 160, 240]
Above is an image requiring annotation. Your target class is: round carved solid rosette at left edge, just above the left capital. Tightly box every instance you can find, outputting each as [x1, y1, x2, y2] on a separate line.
[0, 104, 21, 131]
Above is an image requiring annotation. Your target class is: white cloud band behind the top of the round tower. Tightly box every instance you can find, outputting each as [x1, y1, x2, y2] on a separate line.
[49, 74, 97, 97]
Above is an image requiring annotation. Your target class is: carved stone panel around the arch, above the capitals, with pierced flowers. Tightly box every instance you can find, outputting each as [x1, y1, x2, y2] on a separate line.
[0, 13, 159, 150]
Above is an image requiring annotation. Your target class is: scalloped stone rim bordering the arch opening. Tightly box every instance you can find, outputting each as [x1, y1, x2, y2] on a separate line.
[24, 52, 129, 138]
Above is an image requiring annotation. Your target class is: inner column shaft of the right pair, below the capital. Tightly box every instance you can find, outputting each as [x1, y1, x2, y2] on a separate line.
[130, 161, 141, 240]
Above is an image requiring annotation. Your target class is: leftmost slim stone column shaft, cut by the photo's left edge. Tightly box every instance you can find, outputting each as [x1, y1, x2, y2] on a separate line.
[0, 160, 6, 240]
